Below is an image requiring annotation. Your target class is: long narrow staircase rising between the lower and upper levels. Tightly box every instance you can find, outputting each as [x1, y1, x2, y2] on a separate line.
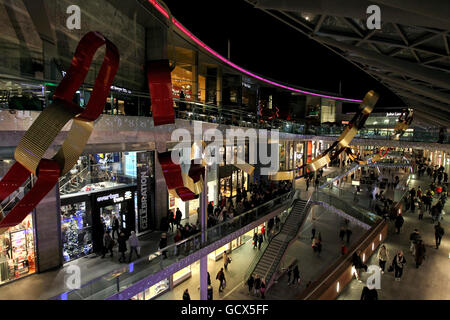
[245, 200, 310, 290]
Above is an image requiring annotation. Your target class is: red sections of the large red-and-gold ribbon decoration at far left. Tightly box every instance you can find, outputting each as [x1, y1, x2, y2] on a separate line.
[0, 32, 119, 228]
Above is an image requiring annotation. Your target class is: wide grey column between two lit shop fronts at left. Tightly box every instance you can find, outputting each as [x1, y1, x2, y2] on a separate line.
[34, 184, 63, 273]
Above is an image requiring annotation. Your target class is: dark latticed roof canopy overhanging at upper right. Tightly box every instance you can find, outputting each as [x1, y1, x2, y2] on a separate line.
[245, 0, 450, 127]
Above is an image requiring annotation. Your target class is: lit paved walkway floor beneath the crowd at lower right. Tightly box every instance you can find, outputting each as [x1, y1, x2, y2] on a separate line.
[338, 177, 450, 300]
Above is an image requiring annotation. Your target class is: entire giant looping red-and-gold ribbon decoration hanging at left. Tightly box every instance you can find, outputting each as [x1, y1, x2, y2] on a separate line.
[0, 32, 119, 232]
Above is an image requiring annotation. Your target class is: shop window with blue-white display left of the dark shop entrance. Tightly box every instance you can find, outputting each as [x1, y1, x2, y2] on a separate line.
[61, 202, 93, 261]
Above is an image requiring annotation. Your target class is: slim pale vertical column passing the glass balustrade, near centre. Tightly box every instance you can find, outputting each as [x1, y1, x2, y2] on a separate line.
[200, 165, 208, 300]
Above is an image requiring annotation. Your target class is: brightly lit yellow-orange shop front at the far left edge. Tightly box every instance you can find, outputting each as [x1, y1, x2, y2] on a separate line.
[0, 213, 36, 284]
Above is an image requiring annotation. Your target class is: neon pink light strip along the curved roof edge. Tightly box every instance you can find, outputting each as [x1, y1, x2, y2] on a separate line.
[148, 0, 362, 103]
